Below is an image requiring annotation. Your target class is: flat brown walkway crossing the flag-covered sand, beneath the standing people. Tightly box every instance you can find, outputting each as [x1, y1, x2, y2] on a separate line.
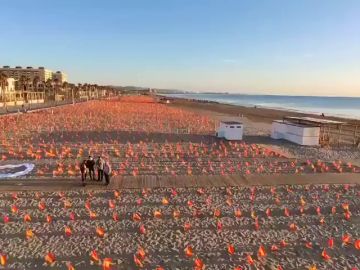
[0, 173, 360, 192]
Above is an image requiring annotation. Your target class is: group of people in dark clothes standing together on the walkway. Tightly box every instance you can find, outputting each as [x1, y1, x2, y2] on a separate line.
[80, 156, 111, 185]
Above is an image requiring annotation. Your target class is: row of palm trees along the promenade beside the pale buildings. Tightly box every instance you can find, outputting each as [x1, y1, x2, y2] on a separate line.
[0, 73, 113, 103]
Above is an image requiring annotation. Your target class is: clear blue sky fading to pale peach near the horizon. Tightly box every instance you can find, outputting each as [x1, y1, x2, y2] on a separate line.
[0, 0, 360, 96]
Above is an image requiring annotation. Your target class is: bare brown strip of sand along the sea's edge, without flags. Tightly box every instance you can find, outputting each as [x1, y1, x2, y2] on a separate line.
[163, 95, 360, 125]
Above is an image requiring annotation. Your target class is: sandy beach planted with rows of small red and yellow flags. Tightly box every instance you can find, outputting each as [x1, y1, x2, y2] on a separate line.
[0, 96, 360, 270]
